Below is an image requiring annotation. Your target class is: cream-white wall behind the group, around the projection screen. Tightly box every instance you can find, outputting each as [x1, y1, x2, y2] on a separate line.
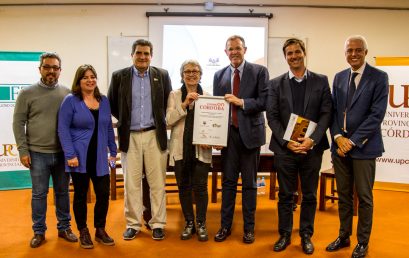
[0, 5, 409, 168]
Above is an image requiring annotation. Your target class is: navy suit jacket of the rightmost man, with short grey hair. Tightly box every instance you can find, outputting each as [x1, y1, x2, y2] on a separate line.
[331, 64, 389, 159]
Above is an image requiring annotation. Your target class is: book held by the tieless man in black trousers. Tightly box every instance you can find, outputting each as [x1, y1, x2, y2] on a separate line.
[283, 113, 317, 142]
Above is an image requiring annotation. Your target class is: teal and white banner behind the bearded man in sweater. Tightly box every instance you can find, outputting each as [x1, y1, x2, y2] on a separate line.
[0, 51, 41, 189]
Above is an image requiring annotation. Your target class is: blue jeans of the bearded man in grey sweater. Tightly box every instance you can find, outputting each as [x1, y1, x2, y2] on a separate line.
[30, 151, 71, 234]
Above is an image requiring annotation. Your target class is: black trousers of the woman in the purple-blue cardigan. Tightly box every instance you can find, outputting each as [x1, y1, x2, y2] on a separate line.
[71, 173, 110, 230]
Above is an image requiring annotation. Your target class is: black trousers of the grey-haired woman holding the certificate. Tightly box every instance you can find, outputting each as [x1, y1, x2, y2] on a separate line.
[175, 160, 210, 222]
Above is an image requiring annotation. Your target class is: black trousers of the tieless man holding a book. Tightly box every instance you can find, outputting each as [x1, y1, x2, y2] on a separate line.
[274, 150, 323, 236]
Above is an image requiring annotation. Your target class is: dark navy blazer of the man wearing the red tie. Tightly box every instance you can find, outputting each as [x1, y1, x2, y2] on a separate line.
[213, 61, 269, 149]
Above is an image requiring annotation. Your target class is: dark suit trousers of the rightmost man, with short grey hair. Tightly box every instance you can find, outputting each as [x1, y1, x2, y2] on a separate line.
[332, 155, 376, 244]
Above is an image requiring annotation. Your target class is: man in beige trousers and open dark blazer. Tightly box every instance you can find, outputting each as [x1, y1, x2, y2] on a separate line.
[108, 39, 172, 240]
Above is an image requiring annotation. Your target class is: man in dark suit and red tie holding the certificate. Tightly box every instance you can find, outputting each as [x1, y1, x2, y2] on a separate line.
[213, 35, 268, 244]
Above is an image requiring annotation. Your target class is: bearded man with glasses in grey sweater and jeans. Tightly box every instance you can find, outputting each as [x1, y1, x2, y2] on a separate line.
[13, 53, 78, 248]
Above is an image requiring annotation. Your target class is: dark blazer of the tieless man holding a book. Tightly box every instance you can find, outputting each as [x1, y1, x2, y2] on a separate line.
[266, 71, 332, 154]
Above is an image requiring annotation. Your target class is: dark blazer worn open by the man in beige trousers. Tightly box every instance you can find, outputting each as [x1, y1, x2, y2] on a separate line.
[108, 66, 172, 152]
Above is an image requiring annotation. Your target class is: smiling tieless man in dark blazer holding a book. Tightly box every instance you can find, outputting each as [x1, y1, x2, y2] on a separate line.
[266, 38, 332, 254]
